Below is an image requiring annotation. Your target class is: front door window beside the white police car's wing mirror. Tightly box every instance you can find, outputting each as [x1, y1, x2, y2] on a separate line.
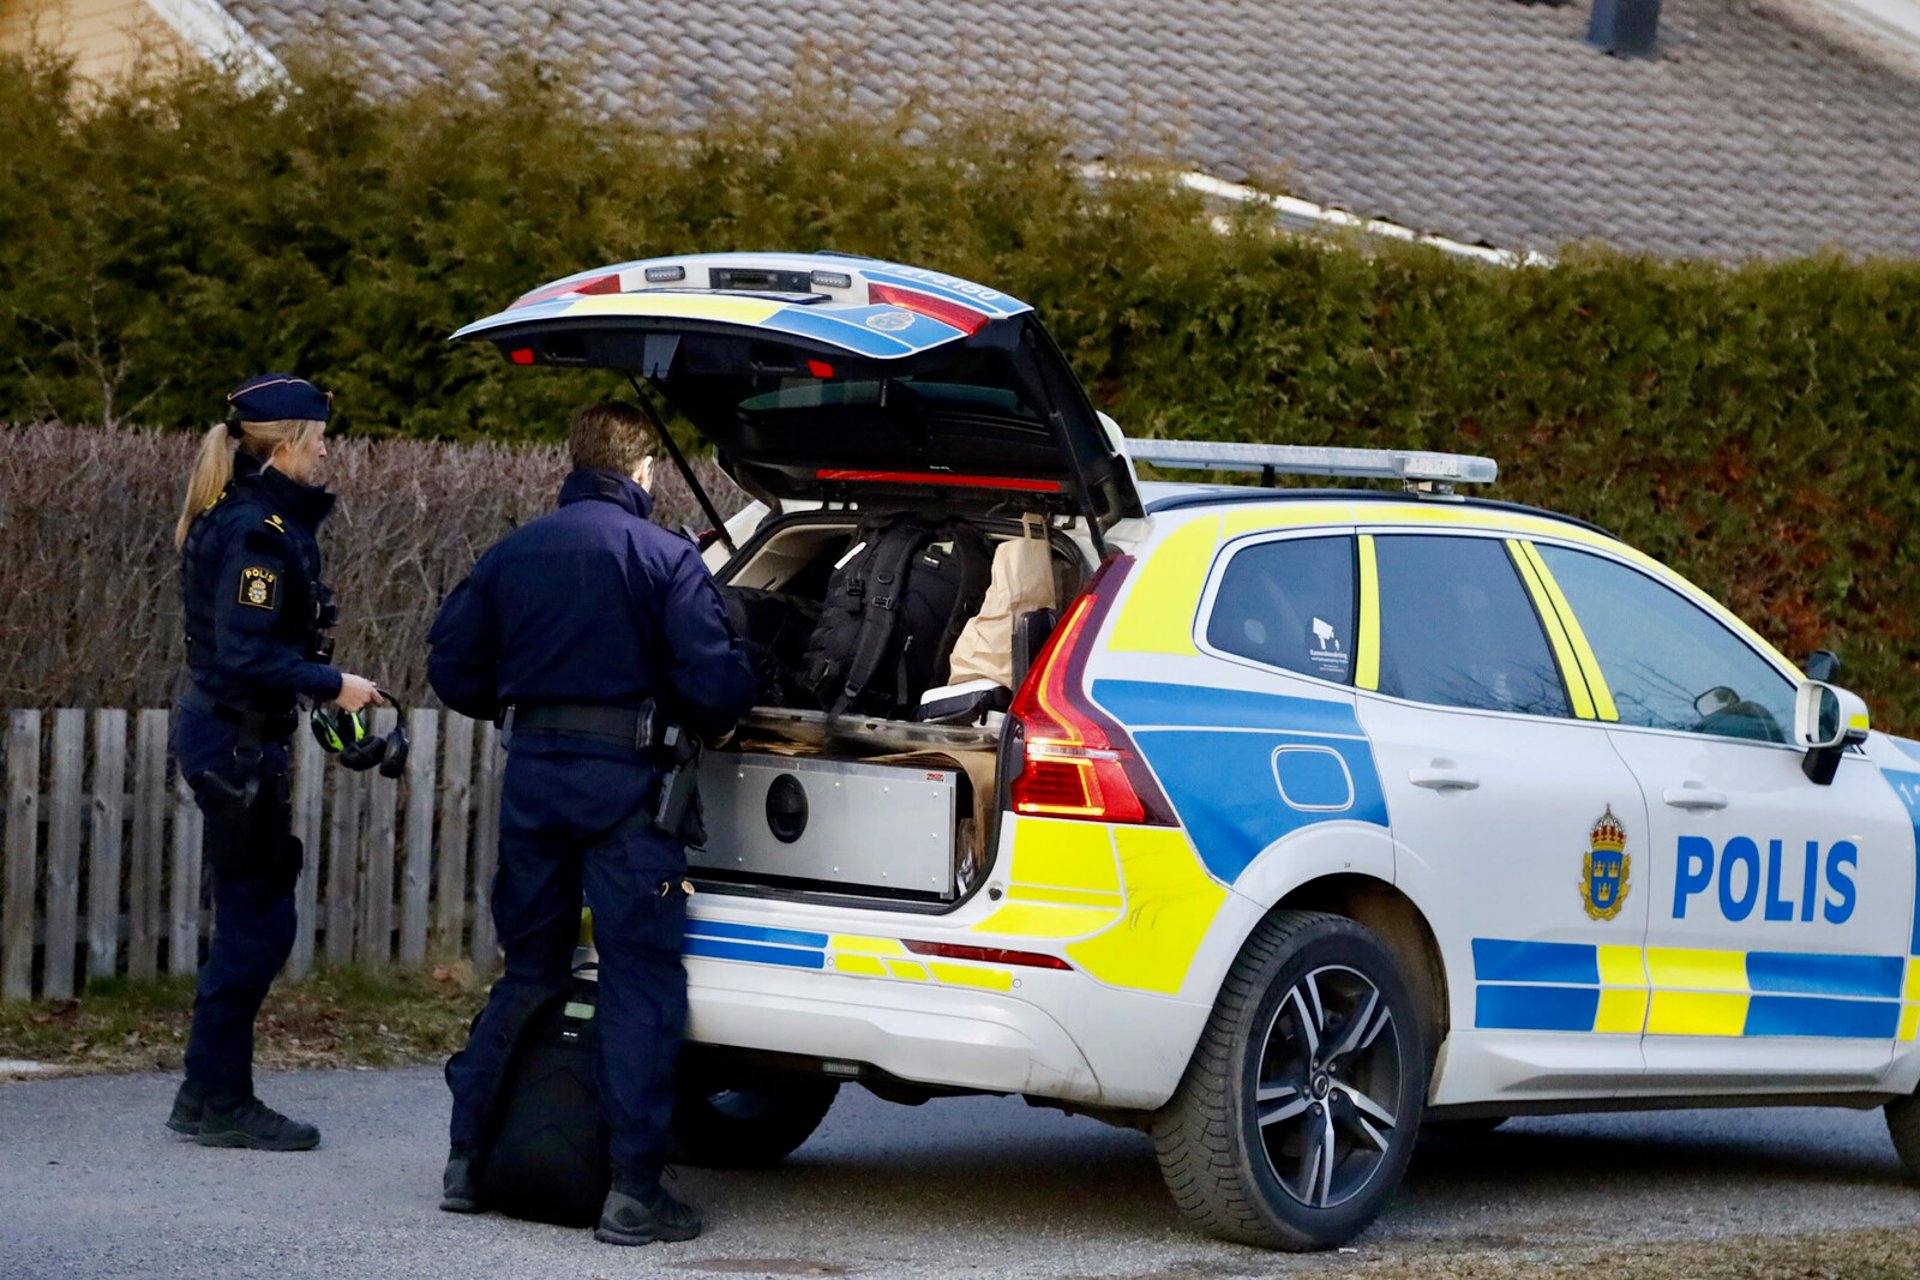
[1540, 545, 1793, 743]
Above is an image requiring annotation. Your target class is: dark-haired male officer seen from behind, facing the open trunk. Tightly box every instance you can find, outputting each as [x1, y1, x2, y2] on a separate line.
[428, 403, 755, 1244]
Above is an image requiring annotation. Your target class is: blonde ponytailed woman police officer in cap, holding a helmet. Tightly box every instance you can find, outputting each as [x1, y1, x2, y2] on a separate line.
[167, 374, 380, 1151]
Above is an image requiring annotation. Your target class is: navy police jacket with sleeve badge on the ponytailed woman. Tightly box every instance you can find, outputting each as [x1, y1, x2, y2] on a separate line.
[180, 453, 340, 714]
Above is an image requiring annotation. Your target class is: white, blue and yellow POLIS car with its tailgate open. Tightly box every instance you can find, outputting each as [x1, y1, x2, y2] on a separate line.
[459, 253, 1920, 1249]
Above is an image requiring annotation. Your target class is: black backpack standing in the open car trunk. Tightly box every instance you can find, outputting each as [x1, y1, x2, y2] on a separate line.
[803, 512, 993, 720]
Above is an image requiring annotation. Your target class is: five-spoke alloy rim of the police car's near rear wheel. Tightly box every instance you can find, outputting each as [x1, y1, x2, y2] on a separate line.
[1254, 965, 1404, 1209]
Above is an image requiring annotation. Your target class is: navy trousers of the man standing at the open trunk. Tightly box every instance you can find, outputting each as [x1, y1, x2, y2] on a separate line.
[447, 741, 687, 1178]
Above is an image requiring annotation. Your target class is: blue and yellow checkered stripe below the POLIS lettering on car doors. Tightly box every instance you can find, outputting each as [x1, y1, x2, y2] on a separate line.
[1473, 938, 1920, 1040]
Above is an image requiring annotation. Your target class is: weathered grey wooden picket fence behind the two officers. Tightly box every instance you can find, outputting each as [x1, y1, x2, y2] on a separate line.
[0, 708, 505, 1000]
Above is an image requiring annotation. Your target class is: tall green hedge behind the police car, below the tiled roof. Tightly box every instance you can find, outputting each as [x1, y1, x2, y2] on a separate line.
[0, 54, 1920, 731]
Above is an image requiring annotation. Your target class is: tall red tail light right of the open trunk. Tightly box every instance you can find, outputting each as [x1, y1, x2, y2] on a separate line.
[1008, 557, 1173, 825]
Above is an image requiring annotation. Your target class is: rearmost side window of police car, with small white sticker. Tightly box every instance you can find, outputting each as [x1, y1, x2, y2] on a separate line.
[1206, 537, 1356, 685]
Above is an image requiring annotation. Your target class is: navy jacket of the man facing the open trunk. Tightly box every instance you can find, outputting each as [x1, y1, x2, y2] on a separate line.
[426, 470, 755, 752]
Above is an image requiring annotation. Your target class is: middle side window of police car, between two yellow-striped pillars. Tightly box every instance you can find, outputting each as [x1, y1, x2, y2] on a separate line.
[1373, 533, 1572, 716]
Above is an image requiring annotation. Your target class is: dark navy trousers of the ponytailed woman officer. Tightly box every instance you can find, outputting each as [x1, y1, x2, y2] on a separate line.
[173, 710, 294, 1103]
